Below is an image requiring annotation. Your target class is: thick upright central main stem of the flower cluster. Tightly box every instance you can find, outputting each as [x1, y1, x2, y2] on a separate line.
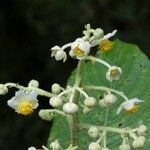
[69, 61, 83, 146]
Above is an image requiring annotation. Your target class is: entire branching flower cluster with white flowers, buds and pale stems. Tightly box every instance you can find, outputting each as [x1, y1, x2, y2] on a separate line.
[0, 24, 147, 150]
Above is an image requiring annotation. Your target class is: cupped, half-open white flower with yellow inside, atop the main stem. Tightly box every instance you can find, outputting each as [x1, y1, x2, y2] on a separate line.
[69, 38, 91, 60]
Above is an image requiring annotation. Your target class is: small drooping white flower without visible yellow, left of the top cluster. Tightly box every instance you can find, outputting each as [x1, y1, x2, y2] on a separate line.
[51, 46, 67, 62]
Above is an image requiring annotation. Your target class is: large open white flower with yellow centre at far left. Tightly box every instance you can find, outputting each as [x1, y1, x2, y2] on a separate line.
[7, 90, 39, 115]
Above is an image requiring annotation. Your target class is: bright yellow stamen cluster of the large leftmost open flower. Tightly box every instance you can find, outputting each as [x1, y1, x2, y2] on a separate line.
[16, 102, 33, 115]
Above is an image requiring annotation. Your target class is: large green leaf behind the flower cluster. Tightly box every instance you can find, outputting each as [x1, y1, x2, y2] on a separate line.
[48, 40, 150, 150]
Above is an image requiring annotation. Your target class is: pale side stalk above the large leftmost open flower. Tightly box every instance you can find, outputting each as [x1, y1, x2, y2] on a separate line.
[5, 83, 55, 97]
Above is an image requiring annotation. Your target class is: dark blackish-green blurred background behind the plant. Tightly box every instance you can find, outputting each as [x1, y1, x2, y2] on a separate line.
[0, 0, 150, 150]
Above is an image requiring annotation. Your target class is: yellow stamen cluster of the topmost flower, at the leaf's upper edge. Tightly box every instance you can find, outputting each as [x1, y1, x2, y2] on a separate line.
[99, 40, 113, 52]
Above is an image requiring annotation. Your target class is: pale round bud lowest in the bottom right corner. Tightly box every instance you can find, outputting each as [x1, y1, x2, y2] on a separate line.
[132, 136, 145, 148]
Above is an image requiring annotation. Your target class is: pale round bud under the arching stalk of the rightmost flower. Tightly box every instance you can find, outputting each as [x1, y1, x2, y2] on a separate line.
[104, 94, 117, 106]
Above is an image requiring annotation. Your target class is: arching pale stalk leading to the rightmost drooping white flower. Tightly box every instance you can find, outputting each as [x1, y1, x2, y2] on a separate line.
[84, 86, 129, 101]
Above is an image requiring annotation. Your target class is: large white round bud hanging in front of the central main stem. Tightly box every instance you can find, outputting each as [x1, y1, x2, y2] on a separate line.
[63, 102, 78, 114]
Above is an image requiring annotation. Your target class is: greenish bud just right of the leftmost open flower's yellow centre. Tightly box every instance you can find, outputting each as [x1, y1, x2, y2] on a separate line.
[39, 110, 54, 121]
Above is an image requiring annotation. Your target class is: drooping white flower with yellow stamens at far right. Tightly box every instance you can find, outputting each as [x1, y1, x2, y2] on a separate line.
[117, 98, 144, 114]
